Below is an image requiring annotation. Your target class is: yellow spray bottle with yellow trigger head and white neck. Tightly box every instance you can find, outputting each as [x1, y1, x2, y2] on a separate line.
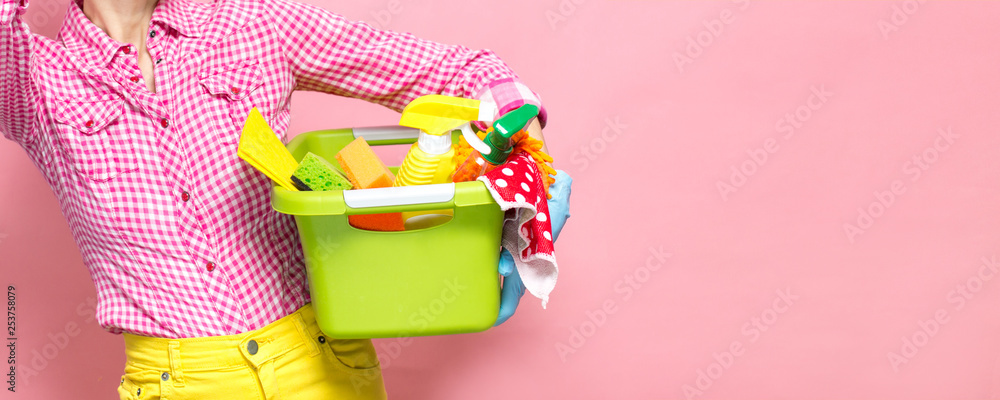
[394, 94, 496, 186]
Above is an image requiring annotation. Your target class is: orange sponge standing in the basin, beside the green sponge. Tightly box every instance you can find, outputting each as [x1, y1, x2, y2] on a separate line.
[337, 137, 405, 231]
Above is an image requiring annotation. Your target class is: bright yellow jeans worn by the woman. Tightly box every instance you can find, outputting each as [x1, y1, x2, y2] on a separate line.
[118, 304, 386, 400]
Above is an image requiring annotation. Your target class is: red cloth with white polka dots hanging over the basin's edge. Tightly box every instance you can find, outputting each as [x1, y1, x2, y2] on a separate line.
[479, 153, 559, 308]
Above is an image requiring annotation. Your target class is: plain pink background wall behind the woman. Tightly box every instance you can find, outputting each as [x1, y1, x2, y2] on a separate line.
[0, 0, 1000, 399]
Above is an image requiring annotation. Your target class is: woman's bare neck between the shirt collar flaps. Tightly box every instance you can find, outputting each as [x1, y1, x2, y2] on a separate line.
[83, 0, 158, 44]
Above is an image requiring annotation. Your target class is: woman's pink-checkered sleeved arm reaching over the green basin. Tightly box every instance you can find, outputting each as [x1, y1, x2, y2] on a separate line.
[268, 0, 546, 128]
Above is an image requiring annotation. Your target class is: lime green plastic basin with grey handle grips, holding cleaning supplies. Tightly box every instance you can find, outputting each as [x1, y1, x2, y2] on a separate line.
[271, 127, 503, 339]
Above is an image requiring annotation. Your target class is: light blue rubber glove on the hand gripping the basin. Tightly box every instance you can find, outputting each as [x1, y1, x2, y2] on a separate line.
[493, 170, 573, 326]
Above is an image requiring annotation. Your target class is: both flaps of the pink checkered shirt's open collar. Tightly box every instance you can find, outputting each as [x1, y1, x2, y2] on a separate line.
[59, 0, 201, 66]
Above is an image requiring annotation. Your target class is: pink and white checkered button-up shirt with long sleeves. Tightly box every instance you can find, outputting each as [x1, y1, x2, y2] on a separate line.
[0, 0, 544, 338]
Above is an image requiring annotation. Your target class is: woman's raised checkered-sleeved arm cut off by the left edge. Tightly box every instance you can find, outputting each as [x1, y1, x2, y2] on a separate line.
[0, 0, 37, 145]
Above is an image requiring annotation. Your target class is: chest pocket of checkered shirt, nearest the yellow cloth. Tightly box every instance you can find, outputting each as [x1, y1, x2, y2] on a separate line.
[199, 61, 262, 143]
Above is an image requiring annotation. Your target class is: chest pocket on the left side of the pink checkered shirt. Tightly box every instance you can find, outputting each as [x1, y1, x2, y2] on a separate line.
[54, 95, 138, 181]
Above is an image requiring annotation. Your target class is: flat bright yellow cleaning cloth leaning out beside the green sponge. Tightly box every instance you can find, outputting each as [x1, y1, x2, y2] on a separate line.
[236, 107, 299, 191]
